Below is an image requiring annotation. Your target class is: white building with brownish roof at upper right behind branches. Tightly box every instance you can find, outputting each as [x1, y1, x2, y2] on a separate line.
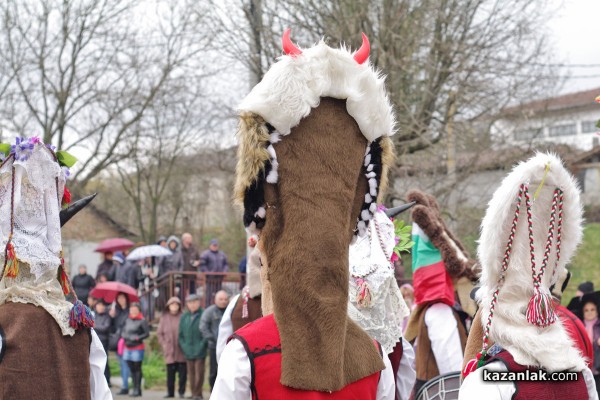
[492, 88, 600, 151]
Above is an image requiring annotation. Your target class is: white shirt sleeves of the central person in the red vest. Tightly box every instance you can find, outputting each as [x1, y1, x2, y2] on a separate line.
[210, 339, 395, 400]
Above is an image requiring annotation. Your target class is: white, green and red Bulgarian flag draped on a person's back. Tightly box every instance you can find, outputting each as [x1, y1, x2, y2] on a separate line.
[411, 222, 454, 307]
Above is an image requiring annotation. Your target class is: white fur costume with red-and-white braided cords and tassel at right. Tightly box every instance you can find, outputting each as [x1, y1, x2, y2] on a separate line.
[460, 153, 597, 399]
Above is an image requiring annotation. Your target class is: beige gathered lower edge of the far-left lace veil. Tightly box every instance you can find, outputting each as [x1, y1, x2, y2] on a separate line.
[0, 262, 75, 336]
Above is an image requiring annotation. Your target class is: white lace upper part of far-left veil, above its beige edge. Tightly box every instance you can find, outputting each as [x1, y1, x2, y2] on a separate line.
[0, 144, 65, 279]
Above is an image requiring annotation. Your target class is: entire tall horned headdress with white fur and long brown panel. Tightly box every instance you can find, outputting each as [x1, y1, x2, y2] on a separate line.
[235, 32, 394, 391]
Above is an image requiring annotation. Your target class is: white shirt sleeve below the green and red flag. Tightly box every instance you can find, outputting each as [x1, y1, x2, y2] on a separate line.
[425, 303, 463, 375]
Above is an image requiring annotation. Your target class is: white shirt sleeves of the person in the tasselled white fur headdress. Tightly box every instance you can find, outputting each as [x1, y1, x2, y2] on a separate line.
[458, 362, 598, 400]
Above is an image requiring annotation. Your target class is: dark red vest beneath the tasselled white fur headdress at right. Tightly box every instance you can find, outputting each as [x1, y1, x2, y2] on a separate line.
[486, 350, 589, 400]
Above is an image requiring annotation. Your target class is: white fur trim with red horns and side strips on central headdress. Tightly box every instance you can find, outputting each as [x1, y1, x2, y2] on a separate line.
[235, 30, 396, 236]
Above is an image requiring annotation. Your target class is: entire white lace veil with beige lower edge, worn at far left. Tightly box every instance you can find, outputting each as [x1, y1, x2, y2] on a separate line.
[0, 142, 75, 335]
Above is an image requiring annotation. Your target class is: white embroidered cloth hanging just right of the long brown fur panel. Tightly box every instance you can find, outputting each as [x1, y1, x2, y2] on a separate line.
[348, 211, 409, 353]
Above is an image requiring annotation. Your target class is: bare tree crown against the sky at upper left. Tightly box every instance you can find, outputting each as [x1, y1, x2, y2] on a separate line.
[0, 0, 210, 188]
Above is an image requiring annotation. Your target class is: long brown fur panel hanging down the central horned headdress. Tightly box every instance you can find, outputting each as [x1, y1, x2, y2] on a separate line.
[261, 98, 384, 391]
